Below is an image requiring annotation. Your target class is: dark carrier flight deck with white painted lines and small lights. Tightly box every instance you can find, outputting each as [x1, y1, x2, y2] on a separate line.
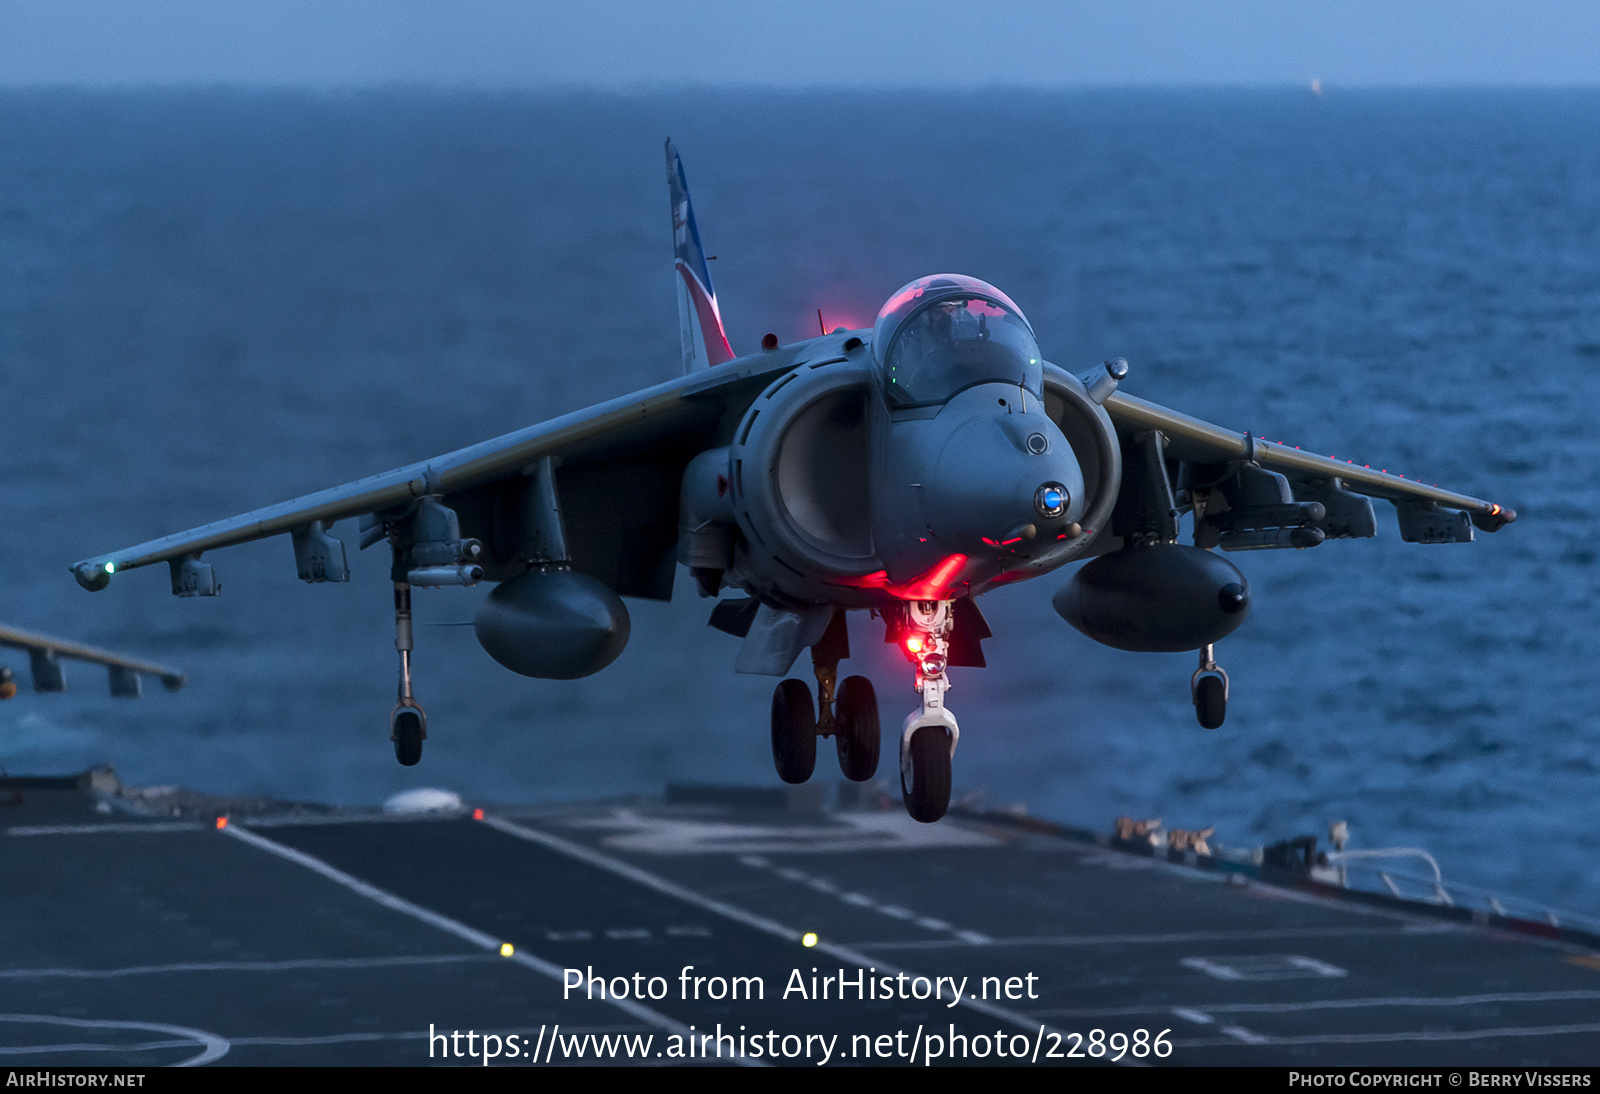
[0, 771, 1600, 1067]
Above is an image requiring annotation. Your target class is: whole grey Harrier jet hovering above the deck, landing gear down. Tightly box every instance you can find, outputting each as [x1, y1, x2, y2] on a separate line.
[72, 141, 1515, 821]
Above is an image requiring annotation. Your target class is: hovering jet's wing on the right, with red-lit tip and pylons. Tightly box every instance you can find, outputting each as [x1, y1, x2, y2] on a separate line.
[1106, 392, 1517, 550]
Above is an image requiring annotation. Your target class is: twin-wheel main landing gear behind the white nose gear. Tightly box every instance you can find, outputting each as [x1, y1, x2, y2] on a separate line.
[773, 611, 880, 782]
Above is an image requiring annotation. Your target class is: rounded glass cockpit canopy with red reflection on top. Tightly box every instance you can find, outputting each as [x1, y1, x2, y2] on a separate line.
[872, 274, 1043, 408]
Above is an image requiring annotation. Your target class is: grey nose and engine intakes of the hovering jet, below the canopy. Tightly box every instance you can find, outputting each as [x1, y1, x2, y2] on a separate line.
[678, 339, 1120, 609]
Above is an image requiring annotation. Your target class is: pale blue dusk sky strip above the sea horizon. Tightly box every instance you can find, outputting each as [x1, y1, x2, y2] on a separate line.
[9, 0, 1600, 88]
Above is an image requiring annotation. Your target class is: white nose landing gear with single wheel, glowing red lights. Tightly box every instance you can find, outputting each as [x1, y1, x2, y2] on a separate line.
[901, 600, 962, 824]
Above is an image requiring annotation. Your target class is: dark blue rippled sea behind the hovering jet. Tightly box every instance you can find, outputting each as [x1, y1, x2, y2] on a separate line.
[0, 88, 1600, 915]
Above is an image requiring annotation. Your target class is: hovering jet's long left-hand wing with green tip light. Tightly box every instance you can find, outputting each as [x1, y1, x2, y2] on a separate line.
[72, 334, 838, 600]
